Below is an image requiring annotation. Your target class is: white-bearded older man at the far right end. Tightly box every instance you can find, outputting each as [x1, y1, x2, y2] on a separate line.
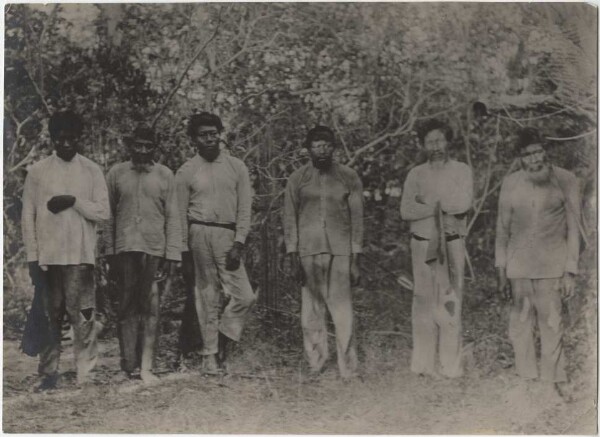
[496, 128, 580, 383]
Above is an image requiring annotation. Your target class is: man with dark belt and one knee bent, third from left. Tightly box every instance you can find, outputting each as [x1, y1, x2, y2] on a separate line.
[176, 112, 256, 374]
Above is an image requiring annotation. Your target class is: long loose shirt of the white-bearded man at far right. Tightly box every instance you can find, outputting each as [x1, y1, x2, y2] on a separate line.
[496, 166, 580, 279]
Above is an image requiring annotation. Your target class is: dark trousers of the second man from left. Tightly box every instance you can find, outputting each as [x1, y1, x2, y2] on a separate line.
[117, 252, 160, 373]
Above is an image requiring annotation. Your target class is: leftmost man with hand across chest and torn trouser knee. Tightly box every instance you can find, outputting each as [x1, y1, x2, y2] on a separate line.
[22, 111, 109, 390]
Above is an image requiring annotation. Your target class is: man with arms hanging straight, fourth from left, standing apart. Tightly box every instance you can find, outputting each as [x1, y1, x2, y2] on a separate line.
[283, 126, 363, 379]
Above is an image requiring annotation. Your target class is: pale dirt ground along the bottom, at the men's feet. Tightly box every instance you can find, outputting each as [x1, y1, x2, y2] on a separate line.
[3, 335, 597, 434]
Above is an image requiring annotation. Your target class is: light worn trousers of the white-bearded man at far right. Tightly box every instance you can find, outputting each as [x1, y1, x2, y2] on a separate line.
[509, 278, 567, 382]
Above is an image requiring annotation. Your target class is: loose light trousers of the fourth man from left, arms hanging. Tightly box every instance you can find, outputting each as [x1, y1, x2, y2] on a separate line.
[301, 253, 358, 378]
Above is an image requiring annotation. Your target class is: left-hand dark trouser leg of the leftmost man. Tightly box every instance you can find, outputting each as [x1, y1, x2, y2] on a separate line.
[38, 266, 65, 376]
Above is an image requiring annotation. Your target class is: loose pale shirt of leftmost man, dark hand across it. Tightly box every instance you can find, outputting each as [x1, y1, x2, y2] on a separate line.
[21, 153, 109, 266]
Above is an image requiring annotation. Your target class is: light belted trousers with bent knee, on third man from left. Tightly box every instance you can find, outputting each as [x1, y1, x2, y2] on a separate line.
[189, 224, 256, 355]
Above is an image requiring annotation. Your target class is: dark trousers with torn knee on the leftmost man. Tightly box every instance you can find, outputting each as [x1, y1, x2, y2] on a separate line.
[38, 264, 98, 379]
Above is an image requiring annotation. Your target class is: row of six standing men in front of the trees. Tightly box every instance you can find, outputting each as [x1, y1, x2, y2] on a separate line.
[22, 111, 579, 390]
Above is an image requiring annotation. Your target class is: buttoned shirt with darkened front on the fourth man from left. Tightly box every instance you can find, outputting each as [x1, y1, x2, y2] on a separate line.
[283, 163, 363, 256]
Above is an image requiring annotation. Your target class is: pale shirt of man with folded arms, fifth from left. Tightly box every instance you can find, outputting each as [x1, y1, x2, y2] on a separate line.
[400, 159, 473, 239]
